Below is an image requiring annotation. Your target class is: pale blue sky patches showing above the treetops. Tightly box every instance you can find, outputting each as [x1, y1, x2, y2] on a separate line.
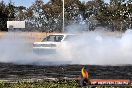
[0, 0, 110, 7]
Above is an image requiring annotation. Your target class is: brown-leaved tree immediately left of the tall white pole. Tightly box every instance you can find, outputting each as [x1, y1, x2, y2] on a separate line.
[43, 0, 63, 32]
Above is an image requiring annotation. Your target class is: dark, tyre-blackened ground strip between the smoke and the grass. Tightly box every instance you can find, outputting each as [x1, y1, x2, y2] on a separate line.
[0, 63, 132, 80]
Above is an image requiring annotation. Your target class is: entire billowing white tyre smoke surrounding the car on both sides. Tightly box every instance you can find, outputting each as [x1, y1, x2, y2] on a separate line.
[0, 26, 132, 65]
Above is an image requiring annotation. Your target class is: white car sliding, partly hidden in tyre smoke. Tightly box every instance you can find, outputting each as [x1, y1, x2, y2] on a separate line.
[33, 34, 75, 54]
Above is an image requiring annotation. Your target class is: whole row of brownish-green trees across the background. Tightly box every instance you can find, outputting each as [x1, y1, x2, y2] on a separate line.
[0, 0, 132, 32]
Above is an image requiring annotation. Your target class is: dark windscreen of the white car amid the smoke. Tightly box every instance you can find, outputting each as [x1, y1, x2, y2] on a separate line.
[42, 35, 64, 42]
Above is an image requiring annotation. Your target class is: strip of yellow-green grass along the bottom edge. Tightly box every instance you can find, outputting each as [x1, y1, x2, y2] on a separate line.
[0, 80, 132, 88]
